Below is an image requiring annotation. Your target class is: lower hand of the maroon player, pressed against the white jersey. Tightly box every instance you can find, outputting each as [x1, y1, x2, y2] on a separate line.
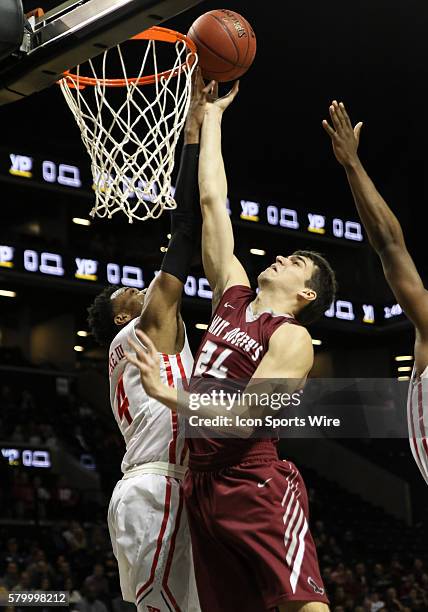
[125, 329, 163, 397]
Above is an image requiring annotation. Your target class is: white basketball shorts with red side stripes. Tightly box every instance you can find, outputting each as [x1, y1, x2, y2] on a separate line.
[108, 474, 200, 612]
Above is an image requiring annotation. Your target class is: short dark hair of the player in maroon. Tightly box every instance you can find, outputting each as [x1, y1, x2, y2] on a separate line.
[293, 251, 337, 325]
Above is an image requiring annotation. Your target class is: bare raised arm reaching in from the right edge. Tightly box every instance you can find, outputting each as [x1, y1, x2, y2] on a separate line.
[323, 101, 428, 374]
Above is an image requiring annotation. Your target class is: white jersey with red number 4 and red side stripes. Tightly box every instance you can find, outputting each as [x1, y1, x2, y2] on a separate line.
[109, 318, 193, 473]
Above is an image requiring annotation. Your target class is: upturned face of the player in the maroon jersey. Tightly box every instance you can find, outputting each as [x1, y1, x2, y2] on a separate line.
[259, 255, 314, 292]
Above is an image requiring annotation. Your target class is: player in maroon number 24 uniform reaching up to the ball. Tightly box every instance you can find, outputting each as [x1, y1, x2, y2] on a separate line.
[127, 79, 335, 612]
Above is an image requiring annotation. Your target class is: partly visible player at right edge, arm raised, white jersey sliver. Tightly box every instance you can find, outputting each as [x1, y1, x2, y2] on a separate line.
[323, 100, 428, 484]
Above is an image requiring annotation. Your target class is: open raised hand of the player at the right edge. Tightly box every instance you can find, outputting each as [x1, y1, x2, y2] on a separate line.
[322, 100, 363, 167]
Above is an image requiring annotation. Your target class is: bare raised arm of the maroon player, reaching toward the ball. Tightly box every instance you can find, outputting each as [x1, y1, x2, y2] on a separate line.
[199, 82, 249, 309]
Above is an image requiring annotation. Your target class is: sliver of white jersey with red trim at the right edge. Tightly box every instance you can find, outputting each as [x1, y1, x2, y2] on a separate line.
[407, 366, 428, 484]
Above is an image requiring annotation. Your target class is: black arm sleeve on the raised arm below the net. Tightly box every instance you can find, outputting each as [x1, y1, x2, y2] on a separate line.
[161, 144, 202, 284]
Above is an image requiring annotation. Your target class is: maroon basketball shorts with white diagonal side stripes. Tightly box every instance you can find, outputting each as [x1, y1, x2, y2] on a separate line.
[184, 452, 328, 612]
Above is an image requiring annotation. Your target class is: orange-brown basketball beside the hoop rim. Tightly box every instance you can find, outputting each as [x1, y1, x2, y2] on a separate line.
[188, 9, 257, 82]
